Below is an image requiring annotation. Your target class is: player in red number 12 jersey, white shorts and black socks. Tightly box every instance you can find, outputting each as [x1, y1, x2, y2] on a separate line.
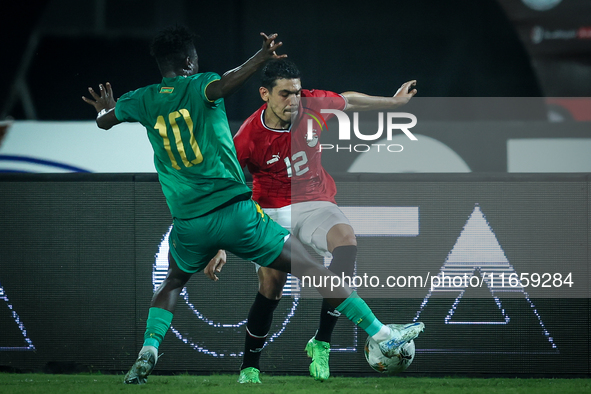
[217, 59, 417, 382]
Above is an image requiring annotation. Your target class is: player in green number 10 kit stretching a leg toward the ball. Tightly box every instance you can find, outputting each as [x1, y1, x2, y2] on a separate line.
[83, 26, 424, 384]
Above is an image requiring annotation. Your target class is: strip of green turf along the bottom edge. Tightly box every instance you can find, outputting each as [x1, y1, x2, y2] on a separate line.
[0, 373, 591, 394]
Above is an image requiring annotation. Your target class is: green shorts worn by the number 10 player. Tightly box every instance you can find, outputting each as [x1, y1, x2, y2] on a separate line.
[168, 199, 289, 273]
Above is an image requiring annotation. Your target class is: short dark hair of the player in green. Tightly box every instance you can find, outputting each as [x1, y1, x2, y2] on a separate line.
[150, 25, 195, 70]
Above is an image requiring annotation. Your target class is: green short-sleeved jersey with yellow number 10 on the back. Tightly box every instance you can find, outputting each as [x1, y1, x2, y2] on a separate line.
[115, 73, 251, 219]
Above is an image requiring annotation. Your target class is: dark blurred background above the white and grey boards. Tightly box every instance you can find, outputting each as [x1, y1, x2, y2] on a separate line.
[0, 0, 591, 121]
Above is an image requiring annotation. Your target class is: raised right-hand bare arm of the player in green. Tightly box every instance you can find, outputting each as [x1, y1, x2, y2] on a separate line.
[205, 33, 287, 101]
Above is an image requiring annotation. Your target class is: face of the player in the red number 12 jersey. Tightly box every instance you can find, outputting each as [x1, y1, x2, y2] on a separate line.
[261, 78, 302, 125]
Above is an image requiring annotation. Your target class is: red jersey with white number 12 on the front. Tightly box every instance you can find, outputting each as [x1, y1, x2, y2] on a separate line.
[234, 89, 346, 208]
